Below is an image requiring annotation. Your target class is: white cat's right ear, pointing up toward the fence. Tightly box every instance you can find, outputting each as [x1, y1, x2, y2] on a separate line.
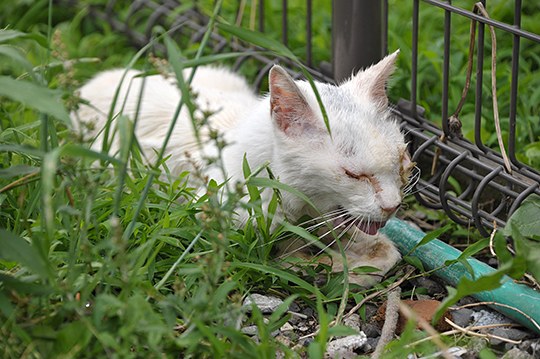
[351, 50, 399, 110]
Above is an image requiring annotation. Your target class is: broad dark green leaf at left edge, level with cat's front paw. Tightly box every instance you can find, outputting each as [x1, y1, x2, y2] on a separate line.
[0, 229, 51, 277]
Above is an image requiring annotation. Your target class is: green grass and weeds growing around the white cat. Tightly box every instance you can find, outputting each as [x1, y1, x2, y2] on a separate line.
[0, 0, 536, 358]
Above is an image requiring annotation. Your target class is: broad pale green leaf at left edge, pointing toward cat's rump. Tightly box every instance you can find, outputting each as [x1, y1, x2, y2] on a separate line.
[0, 76, 71, 126]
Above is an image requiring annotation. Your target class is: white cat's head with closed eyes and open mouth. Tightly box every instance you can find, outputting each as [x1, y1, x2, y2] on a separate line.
[269, 52, 413, 234]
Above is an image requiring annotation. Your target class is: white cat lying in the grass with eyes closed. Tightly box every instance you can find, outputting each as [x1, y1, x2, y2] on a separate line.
[74, 51, 413, 285]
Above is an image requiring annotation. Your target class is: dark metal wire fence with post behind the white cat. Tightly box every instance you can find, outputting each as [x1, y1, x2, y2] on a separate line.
[78, 0, 540, 235]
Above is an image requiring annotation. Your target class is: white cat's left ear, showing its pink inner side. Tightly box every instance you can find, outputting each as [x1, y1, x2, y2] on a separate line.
[269, 65, 316, 136]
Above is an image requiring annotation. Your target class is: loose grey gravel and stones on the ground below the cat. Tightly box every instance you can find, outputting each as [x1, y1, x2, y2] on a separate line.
[241, 294, 540, 359]
